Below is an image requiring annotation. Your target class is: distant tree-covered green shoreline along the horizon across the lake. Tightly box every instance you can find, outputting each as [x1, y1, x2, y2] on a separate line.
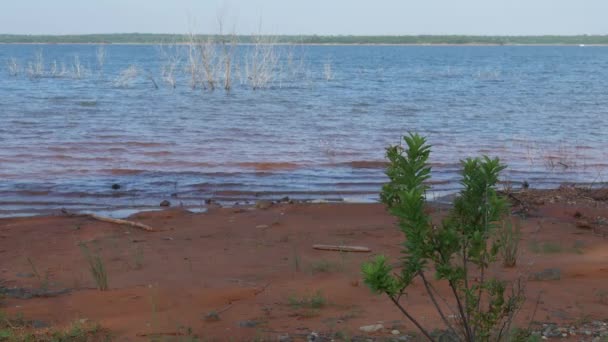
[0, 33, 608, 46]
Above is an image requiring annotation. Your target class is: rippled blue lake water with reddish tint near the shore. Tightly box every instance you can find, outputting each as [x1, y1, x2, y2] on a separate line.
[0, 45, 608, 216]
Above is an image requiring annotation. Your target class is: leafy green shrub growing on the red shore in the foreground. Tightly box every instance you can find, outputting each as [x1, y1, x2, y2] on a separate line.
[362, 134, 524, 342]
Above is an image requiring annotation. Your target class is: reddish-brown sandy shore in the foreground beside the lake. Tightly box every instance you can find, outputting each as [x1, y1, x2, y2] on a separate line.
[0, 190, 608, 341]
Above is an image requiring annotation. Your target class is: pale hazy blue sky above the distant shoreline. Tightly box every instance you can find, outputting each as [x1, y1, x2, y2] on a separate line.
[0, 0, 608, 35]
